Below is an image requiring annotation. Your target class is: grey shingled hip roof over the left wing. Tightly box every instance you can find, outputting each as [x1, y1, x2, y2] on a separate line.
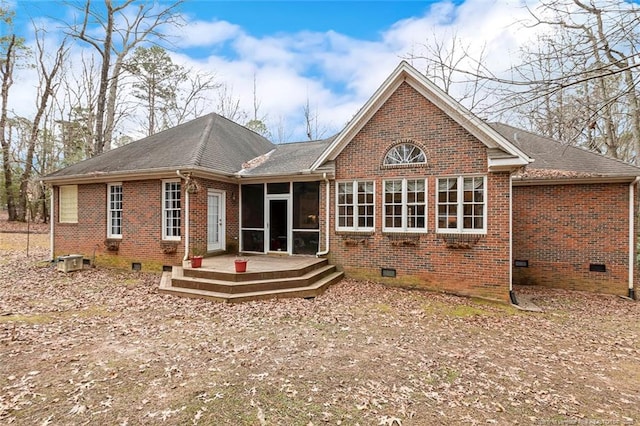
[43, 113, 275, 181]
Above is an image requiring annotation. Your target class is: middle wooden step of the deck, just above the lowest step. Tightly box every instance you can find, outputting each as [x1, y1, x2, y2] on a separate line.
[171, 265, 336, 294]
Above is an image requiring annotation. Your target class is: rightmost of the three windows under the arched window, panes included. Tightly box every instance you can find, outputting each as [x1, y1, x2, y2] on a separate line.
[438, 176, 487, 233]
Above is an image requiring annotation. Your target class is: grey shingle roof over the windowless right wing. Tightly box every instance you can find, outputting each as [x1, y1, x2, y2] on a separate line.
[490, 123, 640, 179]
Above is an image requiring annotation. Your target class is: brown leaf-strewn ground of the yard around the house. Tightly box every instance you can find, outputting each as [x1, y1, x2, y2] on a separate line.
[0, 221, 640, 425]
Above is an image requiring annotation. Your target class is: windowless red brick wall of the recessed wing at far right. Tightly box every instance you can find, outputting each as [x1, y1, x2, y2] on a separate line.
[513, 183, 637, 295]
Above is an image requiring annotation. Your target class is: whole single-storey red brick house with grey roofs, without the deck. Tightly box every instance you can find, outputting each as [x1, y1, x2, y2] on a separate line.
[44, 62, 640, 301]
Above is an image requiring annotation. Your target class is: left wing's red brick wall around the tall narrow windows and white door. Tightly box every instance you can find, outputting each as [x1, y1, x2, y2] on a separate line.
[53, 179, 238, 270]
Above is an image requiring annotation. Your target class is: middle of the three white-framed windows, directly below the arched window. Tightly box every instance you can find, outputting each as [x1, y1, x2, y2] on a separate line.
[383, 179, 427, 232]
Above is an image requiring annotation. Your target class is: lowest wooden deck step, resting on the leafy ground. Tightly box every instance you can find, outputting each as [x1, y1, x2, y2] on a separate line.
[159, 271, 344, 303]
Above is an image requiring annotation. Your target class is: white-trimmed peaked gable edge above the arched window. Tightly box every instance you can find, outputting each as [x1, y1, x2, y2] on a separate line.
[312, 61, 533, 171]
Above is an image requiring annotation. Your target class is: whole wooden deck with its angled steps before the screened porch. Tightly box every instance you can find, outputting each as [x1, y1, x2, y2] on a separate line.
[159, 255, 343, 302]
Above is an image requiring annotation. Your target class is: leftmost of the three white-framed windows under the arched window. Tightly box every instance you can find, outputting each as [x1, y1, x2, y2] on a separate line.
[336, 181, 375, 231]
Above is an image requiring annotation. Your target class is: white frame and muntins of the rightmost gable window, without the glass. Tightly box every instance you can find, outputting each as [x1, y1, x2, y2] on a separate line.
[435, 175, 488, 234]
